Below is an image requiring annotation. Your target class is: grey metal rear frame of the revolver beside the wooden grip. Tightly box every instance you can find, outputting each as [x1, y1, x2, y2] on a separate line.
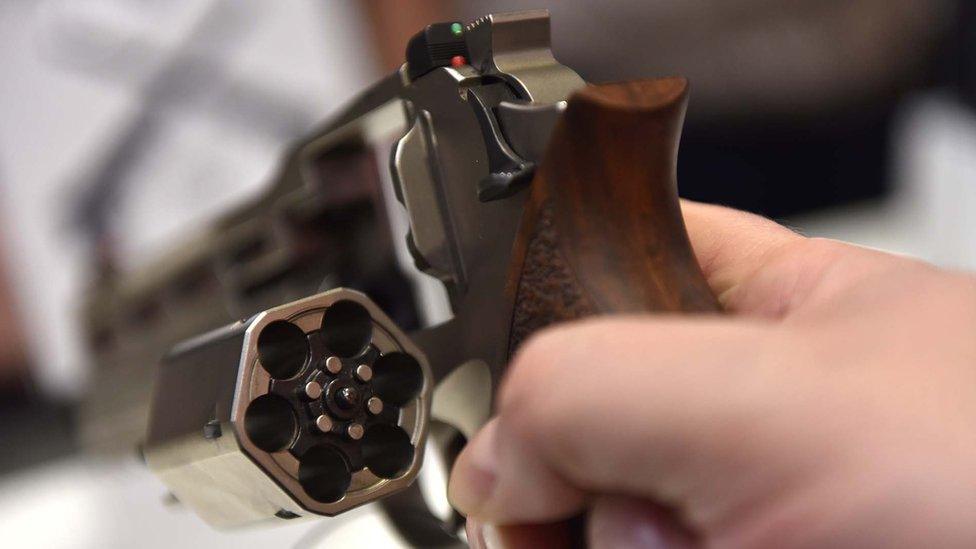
[392, 11, 584, 386]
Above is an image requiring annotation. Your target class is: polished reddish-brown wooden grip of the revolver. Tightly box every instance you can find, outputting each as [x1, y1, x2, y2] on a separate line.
[509, 78, 719, 351]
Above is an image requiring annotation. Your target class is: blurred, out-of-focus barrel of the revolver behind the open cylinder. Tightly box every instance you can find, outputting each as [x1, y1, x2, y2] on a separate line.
[80, 128, 415, 454]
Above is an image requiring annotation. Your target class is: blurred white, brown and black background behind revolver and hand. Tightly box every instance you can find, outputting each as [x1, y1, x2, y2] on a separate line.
[0, 0, 976, 548]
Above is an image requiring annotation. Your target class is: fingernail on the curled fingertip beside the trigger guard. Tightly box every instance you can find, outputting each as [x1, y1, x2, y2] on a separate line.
[448, 421, 497, 515]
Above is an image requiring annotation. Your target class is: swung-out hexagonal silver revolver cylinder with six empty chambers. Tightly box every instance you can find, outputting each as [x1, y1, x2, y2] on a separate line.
[145, 288, 432, 527]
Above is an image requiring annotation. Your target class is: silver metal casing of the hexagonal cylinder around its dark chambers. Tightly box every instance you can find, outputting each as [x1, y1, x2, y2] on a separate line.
[145, 289, 432, 527]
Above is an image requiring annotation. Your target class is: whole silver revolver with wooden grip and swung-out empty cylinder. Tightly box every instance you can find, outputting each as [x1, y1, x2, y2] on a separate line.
[82, 11, 719, 546]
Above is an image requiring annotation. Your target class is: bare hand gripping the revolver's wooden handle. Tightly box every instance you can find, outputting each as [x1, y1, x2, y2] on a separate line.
[450, 203, 976, 548]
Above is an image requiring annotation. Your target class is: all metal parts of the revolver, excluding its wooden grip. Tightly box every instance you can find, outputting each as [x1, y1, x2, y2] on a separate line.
[85, 7, 584, 546]
